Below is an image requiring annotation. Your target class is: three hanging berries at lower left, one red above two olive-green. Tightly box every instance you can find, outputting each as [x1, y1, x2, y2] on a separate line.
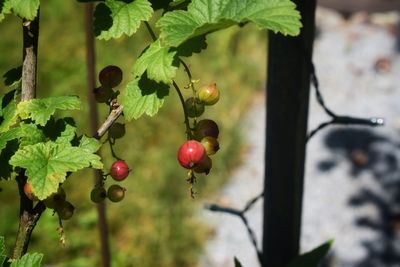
[90, 160, 129, 203]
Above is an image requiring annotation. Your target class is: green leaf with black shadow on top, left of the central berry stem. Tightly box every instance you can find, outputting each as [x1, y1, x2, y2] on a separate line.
[120, 75, 169, 120]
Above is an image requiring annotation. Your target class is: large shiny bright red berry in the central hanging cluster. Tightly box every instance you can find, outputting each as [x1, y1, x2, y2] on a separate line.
[178, 140, 206, 169]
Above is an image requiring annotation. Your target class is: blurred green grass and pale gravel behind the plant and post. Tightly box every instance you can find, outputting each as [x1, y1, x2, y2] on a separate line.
[0, 0, 400, 267]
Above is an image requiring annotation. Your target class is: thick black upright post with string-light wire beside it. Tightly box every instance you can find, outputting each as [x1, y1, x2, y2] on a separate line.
[263, 0, 316, 267]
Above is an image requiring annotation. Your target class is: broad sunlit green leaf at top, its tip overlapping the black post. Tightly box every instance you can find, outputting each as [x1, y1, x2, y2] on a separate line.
[157, 0, 301, 47]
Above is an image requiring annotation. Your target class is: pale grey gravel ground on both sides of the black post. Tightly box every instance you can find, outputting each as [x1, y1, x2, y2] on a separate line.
[200, 9, 400, 267]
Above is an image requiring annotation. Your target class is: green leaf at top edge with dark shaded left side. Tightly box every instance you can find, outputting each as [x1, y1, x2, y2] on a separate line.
[94, 0, 153, 40]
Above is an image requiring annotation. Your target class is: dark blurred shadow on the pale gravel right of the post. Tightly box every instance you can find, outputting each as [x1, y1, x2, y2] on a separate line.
[318, 128, 400, 267]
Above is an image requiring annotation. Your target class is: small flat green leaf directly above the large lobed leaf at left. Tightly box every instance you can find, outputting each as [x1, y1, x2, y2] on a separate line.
[18, 96, 81, 126]
